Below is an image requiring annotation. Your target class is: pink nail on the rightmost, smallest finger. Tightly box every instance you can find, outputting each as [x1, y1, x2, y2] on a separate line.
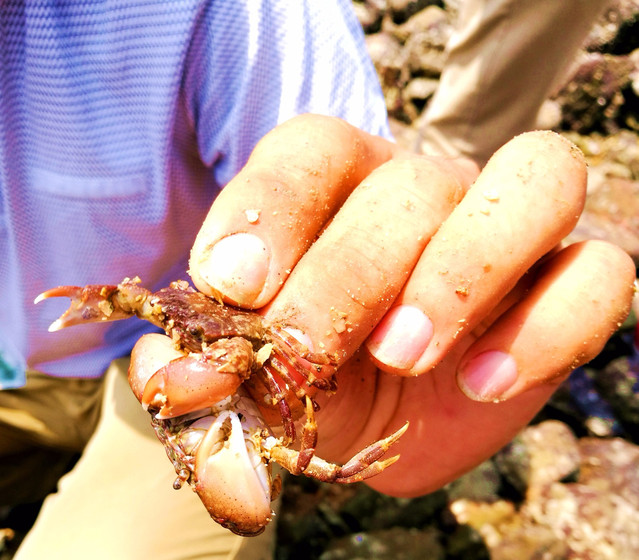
[457, 350, 517, 402]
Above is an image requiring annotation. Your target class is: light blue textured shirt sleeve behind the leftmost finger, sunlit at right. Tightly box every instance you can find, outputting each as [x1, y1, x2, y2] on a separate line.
[183, 0, 390, 185]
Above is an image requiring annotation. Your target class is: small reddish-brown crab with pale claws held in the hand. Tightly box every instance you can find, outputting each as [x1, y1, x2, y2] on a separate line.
[36, 278, 408, 536]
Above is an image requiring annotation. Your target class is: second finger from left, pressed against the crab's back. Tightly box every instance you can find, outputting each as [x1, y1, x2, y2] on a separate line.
[267, 157, 478, 363]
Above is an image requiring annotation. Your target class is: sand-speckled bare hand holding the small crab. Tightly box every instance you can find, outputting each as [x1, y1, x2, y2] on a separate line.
[136, 115, 635, 496]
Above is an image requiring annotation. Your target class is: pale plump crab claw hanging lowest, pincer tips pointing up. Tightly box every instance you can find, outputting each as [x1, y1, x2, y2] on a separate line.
[194, 411, 273, 536]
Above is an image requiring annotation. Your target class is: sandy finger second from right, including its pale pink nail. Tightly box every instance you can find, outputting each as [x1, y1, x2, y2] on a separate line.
[367, 132, 586, 375]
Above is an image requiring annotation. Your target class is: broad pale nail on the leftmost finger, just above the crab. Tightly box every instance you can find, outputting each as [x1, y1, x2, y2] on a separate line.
[198, 233, 270, 305]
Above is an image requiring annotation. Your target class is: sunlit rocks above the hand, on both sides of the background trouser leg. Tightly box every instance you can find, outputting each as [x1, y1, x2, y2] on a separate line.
[360, 0, 639, 262]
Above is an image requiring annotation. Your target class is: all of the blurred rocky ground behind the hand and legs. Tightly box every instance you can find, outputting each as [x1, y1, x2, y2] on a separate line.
[276, 0, 639, 560]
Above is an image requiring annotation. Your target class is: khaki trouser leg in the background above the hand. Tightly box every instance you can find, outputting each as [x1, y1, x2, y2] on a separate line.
[420, 0, 610, 166]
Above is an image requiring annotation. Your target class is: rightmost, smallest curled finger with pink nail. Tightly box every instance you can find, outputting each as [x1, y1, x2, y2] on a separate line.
[458, 241, 635, 401]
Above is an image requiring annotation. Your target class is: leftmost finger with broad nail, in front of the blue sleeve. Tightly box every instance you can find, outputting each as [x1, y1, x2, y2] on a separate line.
[190, 115, 397, 308]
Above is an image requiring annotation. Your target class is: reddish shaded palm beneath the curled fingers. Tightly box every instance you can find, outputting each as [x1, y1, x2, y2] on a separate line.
[317, 343, 553, 496]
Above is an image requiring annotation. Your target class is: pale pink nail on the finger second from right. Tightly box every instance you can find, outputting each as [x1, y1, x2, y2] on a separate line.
[366, 305, 433, 369]
